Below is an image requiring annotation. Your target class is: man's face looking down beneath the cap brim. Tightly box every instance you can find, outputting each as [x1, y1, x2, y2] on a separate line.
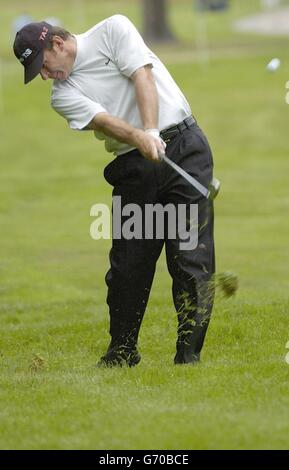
[40, 36, 74, 81]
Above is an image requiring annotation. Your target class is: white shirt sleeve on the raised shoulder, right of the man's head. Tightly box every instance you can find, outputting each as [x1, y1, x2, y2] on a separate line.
[107, 15, 152, 77]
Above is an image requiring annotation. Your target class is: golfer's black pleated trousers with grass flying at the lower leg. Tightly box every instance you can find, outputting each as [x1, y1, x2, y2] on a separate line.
[104, 123, 215, 362]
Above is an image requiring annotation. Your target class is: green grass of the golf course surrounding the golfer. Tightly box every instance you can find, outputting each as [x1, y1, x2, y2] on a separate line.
[0, 0, 289, 449]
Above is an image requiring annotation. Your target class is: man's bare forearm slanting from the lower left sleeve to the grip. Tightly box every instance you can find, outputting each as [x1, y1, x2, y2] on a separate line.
[87, 113, 163, 161]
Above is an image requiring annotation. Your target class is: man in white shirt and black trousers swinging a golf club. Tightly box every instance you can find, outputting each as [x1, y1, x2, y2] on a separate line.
[14, 15, 215, 367]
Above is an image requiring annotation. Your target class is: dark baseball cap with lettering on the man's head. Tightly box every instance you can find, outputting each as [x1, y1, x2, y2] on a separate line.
[13, 21, 52, 84]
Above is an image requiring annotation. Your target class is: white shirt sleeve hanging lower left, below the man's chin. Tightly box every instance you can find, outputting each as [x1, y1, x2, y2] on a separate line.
[51, 83, 107, 130]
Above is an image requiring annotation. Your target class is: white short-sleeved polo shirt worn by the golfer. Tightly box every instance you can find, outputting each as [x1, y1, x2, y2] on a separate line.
[51, 15, 191, 154]
